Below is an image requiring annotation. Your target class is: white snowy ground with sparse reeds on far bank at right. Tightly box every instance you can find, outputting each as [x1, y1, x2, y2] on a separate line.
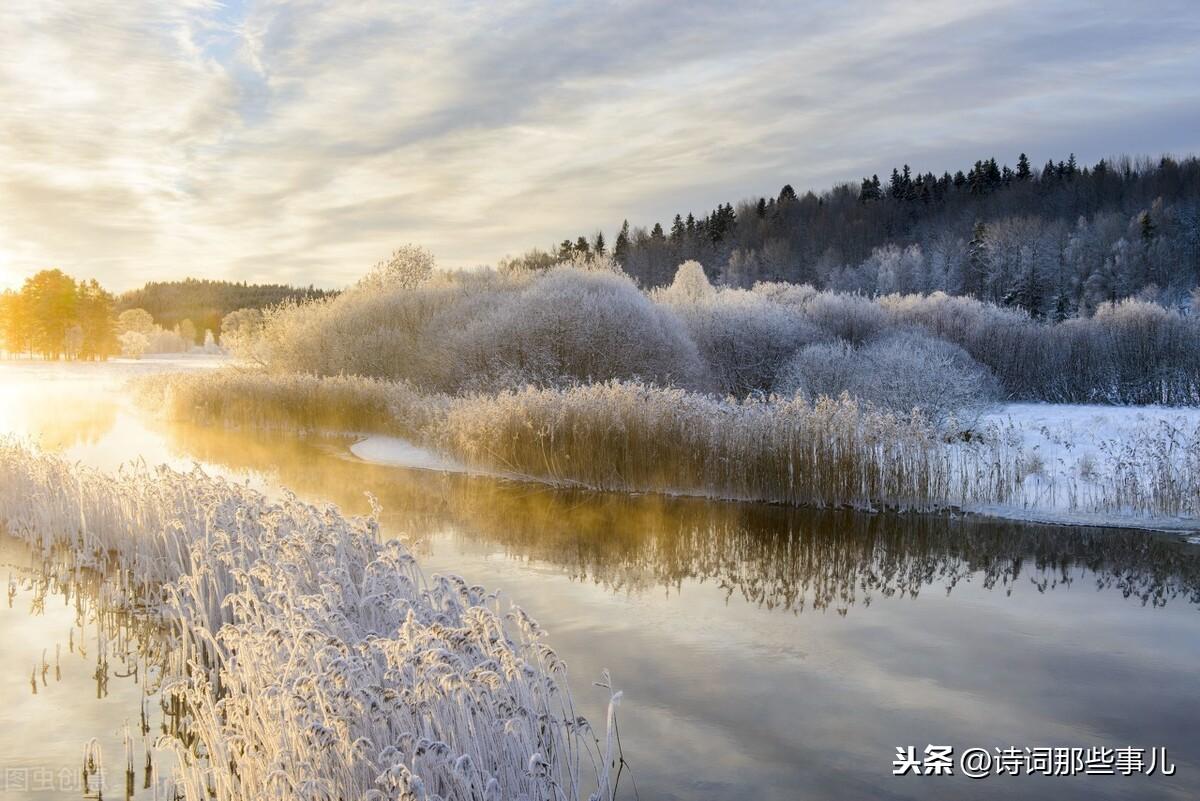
[968, 403, 1200, 530]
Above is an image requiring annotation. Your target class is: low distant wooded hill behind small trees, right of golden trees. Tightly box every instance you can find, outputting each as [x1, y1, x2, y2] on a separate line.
[118, 278, 332, 336]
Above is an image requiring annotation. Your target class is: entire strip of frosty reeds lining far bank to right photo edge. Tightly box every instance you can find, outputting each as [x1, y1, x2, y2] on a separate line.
[139, 371, 1200, 520]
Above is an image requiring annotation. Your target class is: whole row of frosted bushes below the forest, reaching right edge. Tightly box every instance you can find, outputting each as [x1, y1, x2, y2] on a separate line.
[230, 245, 1200, 409]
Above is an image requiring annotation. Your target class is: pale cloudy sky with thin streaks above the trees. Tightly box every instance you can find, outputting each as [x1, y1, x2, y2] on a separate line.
[0, 0, 1200, 290]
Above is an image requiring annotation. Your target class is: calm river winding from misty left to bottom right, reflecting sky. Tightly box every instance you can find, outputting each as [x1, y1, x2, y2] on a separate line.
[0, 366, 1200, 799]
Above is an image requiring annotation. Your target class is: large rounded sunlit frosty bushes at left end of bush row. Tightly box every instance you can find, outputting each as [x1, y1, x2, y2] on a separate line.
[242, 266, 703, 392]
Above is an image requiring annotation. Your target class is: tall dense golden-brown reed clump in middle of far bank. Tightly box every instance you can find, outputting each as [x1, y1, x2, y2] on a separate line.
[433, 381, 1012, 510]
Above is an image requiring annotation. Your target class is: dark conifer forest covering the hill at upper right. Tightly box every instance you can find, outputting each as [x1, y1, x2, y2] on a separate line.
[532, 153, 1200, 320]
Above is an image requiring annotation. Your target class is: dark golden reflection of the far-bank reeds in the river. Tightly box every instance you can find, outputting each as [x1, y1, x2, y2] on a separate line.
[159, 426, 1200, 613]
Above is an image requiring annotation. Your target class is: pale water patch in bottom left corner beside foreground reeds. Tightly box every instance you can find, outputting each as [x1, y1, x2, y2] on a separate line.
[0, 534, 174, 801]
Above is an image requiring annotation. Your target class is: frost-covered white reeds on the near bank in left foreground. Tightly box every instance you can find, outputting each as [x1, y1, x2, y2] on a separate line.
[0, 440, 619, 801]
